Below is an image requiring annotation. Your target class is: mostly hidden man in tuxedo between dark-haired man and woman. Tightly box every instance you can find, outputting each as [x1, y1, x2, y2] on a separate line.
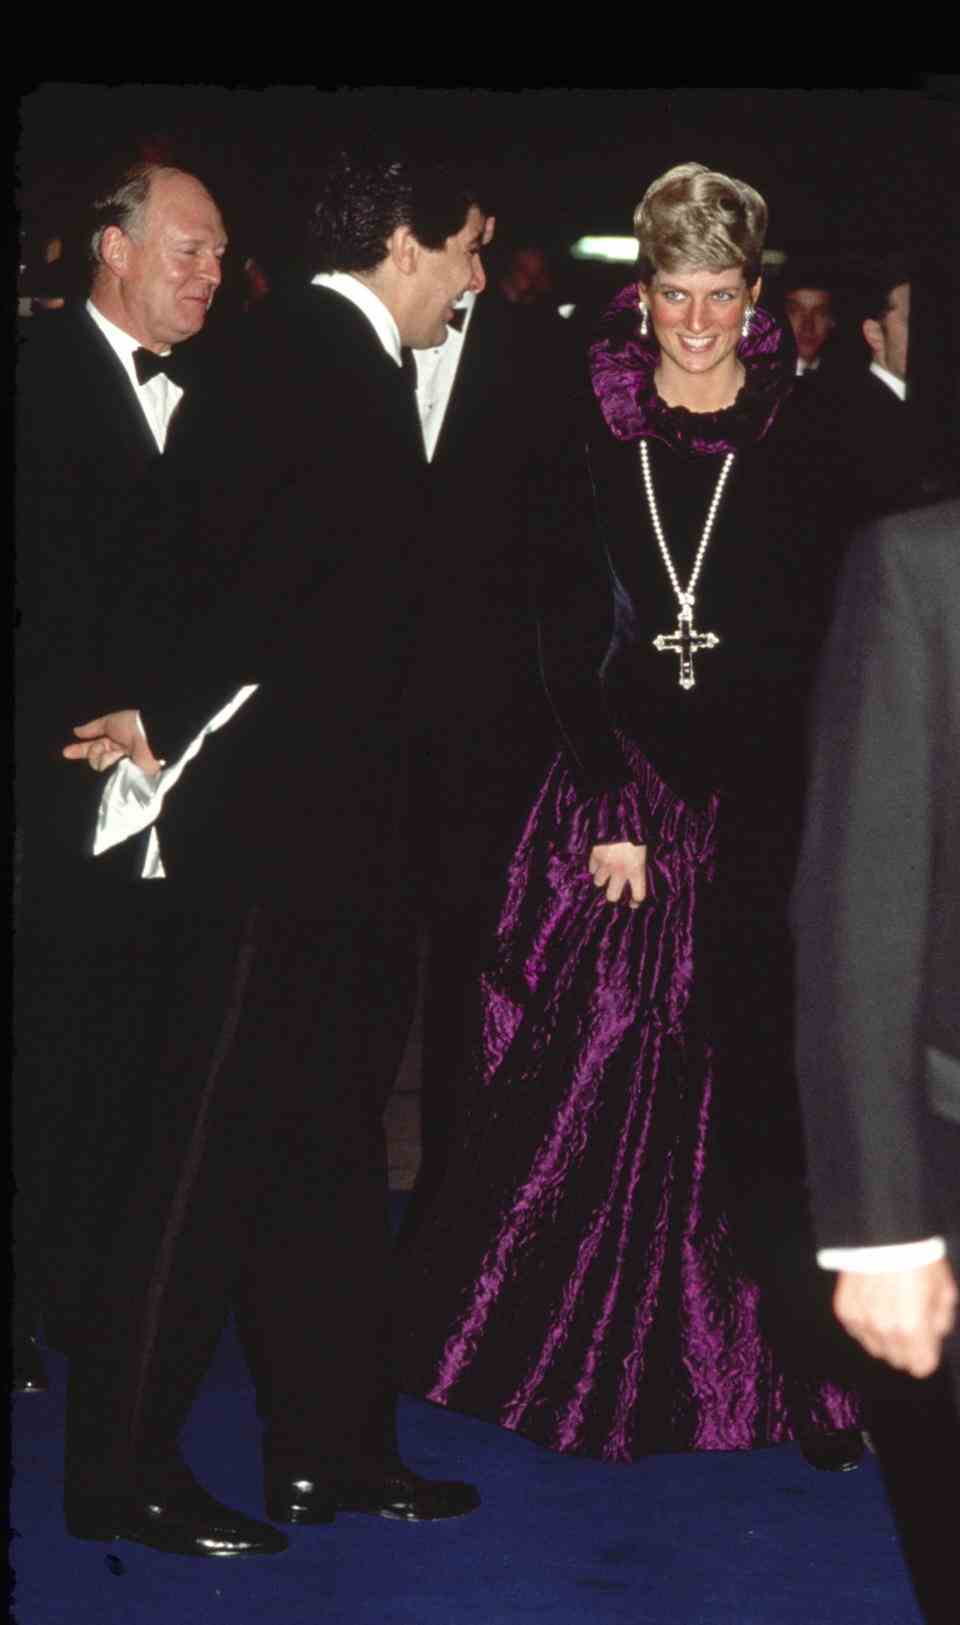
[404, 269, 572, 1233]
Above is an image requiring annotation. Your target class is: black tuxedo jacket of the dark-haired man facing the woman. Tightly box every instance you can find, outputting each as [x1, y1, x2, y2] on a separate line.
[129, 288, 430, 913]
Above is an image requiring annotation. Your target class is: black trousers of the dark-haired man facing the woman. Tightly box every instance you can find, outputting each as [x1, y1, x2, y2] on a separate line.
[67, 905, 416, 1493]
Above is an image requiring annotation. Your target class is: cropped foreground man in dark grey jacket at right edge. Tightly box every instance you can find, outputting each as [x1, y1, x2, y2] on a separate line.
[794, 501, 960, 1622]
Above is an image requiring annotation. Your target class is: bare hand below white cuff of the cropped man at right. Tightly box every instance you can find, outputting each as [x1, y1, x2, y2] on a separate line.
[833, 1258, 958, 1376]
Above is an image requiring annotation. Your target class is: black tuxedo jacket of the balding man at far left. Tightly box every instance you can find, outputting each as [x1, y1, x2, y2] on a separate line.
[16, 307, 214, 902]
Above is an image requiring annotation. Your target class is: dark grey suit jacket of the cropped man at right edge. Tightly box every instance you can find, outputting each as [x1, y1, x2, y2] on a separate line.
[794, 502, 960, 1246]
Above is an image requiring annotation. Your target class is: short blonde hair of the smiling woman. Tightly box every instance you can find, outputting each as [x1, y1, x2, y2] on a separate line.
[634, 164, 767, 284]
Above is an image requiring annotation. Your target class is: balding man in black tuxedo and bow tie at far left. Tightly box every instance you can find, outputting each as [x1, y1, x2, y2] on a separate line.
[15, 164, 226, 1391]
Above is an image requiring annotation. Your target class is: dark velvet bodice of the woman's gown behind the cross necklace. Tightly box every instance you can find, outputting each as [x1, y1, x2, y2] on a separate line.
[591, 437, 824, 800]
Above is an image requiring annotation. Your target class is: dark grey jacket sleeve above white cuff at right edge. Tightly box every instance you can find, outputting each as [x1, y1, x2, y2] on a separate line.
[794, 528, 939, 1246]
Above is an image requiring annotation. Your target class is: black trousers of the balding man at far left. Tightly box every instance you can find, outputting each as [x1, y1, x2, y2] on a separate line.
[13, 860, 171, 1349]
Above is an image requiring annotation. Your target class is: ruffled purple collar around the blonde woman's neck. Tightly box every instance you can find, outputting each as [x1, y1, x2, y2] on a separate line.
[590, 283, 794, 457]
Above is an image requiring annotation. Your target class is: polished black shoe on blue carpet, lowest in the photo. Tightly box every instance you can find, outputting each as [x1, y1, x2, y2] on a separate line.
[63, 1485, 288, 1557]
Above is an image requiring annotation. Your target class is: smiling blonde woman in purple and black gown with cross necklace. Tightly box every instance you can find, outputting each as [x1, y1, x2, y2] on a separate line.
[398, 164, 858, 1464]
